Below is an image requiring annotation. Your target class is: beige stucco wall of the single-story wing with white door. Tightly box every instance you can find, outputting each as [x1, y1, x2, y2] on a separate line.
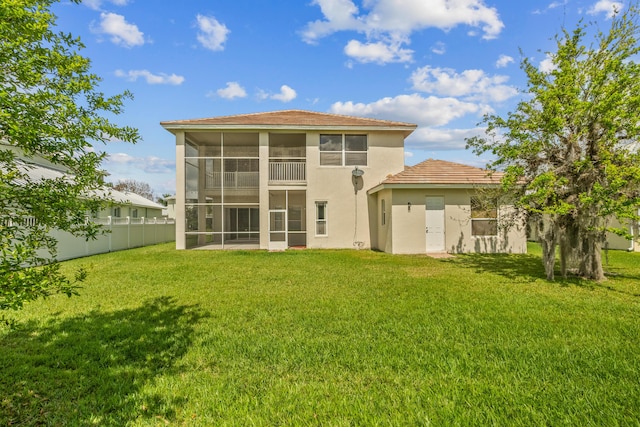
[378, 188, 527, 254]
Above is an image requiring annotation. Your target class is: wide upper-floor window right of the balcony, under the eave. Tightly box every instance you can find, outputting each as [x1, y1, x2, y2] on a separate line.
[320, 135, 368, 166]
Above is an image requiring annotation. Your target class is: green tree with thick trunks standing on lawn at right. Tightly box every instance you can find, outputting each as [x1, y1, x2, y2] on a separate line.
[467, 4, 640, 280]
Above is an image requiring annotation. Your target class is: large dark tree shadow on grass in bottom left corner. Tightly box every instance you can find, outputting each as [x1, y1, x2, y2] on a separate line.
[0, 297, 204, 426]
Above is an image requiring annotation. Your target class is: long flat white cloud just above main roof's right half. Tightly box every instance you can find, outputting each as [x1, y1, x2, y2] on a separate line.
[330, 94, 493, 126]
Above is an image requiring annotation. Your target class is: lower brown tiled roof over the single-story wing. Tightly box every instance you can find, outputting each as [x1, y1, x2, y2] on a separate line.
[382, 159, 503, 185]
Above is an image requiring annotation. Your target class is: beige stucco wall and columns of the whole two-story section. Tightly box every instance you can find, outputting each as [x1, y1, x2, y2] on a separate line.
[175, 129, 404, 249]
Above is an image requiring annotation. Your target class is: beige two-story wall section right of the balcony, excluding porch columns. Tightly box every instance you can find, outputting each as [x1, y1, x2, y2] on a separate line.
[307, 132, 404, 248]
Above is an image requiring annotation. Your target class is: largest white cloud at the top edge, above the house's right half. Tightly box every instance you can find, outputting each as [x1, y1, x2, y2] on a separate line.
[302, 0, 504, 63]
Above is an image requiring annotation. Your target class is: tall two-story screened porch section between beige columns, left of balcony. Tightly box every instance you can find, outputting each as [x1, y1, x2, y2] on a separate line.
[185, 132, 260, 249]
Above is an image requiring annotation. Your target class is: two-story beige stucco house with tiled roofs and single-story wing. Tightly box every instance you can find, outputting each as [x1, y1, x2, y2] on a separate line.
[161, 110, 526, 253]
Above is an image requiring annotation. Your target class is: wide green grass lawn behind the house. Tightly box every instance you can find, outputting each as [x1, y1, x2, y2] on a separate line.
[0, 245, 640, 426]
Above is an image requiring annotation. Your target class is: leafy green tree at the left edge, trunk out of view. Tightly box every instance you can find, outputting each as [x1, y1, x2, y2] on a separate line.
[0, 0, 139, 320]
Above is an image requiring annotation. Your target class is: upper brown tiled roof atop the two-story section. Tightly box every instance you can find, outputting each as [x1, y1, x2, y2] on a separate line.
[160, 110, 417, 131]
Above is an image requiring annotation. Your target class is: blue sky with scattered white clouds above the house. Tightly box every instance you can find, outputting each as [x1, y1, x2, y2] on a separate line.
[53, 0, 624, 195]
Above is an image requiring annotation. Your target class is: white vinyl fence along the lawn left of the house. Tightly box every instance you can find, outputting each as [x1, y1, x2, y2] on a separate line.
[51, 217, 176, 261]
